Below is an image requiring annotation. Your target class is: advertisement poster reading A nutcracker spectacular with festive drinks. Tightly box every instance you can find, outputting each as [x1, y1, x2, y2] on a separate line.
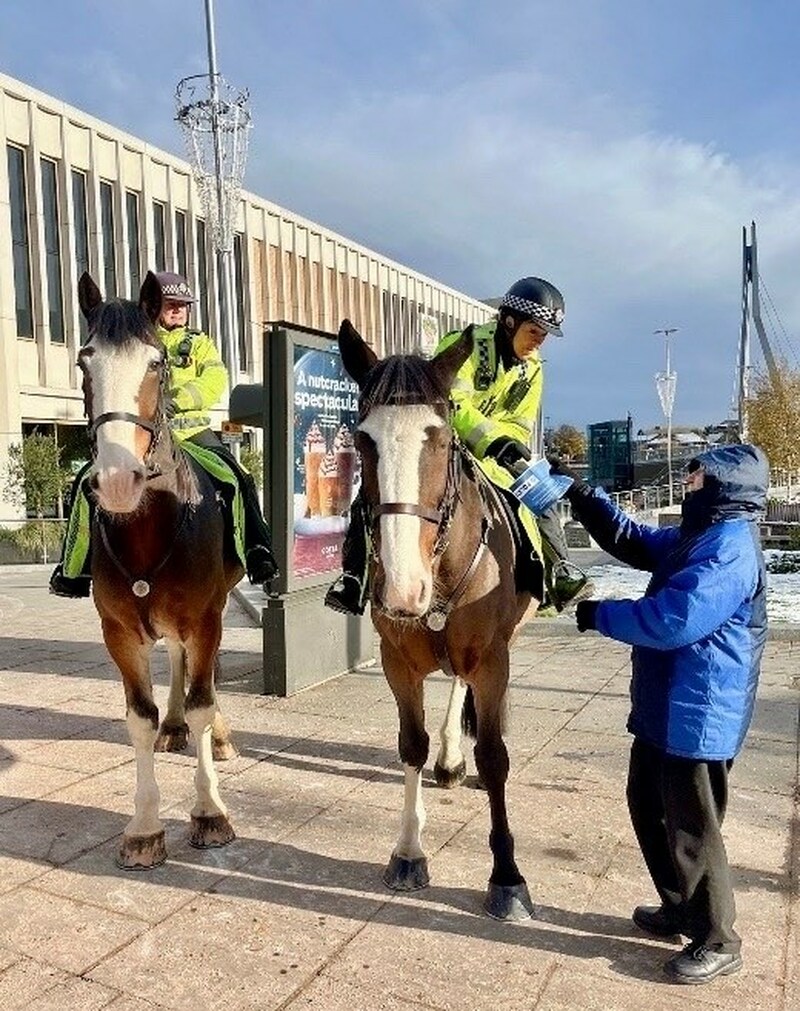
[292, 346, 360, 578]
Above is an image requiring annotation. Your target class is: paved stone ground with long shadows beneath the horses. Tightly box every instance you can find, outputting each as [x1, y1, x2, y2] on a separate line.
[0, 566, 800, 1011]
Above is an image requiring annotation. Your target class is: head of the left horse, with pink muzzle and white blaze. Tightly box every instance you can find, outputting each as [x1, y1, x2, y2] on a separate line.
[78, 271, 169, 513]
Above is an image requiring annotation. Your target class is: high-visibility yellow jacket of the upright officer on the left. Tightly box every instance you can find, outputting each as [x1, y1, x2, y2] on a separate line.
[158, 327, 228, 442]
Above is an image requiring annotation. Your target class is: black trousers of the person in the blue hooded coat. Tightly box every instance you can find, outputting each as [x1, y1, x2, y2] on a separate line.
[627, 739, 741, 952]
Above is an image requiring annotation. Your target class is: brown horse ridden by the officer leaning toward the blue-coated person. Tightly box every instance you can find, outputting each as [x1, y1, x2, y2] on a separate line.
[339, 319, 538, 920]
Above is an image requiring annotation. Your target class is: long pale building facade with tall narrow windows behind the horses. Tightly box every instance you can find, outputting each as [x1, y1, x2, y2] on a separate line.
[0, 74, 493, 525]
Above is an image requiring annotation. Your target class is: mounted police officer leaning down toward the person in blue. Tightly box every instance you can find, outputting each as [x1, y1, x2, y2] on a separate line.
[325, 277, 592, 614]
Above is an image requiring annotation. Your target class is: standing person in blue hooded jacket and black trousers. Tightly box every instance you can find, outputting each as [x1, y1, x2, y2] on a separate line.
[553, 446, 769, 983]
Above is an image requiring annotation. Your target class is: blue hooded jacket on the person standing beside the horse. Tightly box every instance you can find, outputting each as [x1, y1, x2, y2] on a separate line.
[569, 446, 769, 761]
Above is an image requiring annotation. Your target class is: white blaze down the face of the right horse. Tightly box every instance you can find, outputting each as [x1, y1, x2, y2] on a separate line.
[359, 404, 445, 615]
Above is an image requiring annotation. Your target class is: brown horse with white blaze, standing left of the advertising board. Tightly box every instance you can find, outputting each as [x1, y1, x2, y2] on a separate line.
[78, 272, 243, 868]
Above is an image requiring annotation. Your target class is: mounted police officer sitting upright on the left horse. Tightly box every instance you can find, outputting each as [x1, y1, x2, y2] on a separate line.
[50, 271, 278, 596]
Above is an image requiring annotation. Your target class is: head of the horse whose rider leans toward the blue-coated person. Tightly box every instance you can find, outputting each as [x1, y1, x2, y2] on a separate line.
[339, 319, 472, 618]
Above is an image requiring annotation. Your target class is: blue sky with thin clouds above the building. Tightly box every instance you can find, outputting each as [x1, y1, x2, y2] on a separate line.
[0, 0, 800, 428]
